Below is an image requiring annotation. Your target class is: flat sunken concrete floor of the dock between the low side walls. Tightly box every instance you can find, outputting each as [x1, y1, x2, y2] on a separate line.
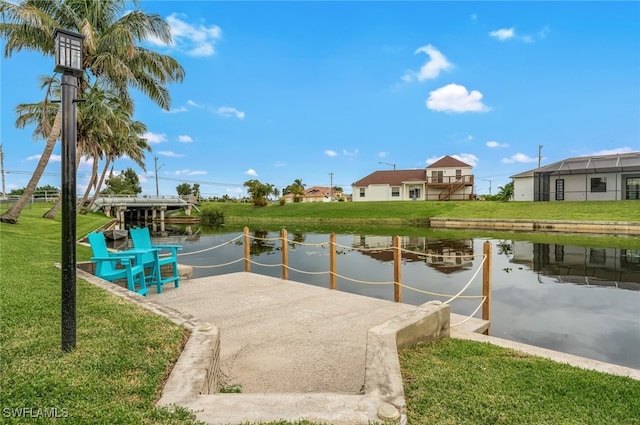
[150, 273, 416, 394]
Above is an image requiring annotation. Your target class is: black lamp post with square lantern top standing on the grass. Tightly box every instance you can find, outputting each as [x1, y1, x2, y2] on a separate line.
[53, 29, 83, 351]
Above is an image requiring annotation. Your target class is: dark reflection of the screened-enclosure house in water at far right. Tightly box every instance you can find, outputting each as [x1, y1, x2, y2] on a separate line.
[511, 242, 640, 291]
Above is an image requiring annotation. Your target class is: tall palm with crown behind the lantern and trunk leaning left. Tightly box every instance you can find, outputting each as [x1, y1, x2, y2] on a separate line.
[0, 0, 184, 223]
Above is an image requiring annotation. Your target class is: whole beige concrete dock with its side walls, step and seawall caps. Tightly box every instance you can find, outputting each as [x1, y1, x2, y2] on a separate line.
[78, 271, 640, 424]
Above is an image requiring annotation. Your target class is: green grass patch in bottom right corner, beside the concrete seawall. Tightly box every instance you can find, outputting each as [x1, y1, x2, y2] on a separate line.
[400, 339, 640, 425]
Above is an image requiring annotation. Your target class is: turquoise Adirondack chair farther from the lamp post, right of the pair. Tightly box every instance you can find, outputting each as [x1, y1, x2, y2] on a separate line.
[129, 227, 182, 294]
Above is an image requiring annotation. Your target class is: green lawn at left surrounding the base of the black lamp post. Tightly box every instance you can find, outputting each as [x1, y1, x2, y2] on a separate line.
[0, 204, 198, 424]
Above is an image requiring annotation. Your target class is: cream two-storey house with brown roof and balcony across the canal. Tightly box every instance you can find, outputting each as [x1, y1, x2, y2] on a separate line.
[352, 155, 473, 202]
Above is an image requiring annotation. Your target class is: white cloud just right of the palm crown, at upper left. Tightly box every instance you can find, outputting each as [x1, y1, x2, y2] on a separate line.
[149, 13, 222, 56]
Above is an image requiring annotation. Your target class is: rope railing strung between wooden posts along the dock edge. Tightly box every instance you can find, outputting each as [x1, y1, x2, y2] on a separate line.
[172, 227, 491, 333]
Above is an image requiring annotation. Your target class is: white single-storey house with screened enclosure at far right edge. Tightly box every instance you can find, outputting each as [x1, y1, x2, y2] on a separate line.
[511, 152, 640, 201]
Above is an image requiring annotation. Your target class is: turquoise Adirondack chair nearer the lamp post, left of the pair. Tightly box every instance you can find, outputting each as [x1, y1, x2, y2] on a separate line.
[87, 232, 149, 295]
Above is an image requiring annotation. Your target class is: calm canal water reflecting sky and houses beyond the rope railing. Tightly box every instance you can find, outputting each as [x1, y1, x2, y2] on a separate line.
[145, 227, 640, 369]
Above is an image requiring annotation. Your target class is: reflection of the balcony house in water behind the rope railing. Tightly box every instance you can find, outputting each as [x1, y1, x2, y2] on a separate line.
[353, 235, 473, 274]
